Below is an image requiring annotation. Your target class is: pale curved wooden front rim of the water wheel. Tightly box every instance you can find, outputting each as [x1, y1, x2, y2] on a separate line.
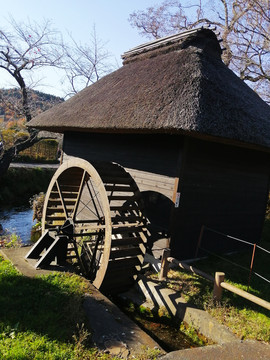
[42, 158, 112, 288]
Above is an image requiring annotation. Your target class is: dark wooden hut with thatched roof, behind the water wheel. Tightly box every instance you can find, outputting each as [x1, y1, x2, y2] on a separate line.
[30, 29, 270, 258]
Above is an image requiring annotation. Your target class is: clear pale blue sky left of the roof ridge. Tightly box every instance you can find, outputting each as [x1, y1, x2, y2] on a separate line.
[0, 0, 162, 96]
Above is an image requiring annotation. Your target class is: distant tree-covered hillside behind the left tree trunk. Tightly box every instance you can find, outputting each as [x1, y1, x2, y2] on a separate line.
[0, 88, 64, 121]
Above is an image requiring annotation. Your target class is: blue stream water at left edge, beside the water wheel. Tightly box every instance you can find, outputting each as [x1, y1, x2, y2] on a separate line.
[0, 207, 34, 244]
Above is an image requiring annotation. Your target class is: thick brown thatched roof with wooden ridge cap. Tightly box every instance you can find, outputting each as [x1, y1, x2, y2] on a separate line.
[27, 29, 270, 147]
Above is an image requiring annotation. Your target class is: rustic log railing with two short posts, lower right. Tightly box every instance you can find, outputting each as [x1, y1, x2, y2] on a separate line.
[159, 249, 270, 310]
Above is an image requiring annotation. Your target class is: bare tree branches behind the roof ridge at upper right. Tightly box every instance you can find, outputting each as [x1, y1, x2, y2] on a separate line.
[129, 0, 270, 101]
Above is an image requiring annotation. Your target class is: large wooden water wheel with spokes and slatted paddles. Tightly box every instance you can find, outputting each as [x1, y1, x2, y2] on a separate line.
[42, 158, 147, 292]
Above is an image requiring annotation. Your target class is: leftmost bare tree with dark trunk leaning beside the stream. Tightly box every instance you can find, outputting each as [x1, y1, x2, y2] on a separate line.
[0, 19, 62, 176]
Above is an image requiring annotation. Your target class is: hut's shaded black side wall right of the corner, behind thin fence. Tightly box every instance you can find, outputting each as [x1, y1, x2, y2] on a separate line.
[171, 139, 269, 259]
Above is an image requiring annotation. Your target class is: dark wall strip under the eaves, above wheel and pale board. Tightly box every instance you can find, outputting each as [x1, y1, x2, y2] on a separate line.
[64, 133, 183, 177]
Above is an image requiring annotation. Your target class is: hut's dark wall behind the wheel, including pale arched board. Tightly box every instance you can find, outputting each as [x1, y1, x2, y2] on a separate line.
[63, 133, 183, 233]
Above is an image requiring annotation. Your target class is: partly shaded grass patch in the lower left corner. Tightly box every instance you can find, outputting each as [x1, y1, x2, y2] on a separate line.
[0, 257, 117, 360]
